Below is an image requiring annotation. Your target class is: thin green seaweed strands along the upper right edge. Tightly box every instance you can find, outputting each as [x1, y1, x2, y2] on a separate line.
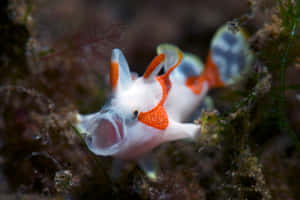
[258, 0, 300, 149]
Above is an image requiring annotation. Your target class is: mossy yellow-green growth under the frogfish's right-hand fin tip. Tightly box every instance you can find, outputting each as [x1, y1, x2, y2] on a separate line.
[197, 67, 271, 199]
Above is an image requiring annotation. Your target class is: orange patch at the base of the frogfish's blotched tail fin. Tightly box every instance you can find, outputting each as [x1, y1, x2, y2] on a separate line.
[185, 52, 225, 94]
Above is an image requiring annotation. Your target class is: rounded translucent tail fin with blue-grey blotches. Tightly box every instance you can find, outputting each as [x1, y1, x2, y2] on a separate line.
[210, 25, 253, 85]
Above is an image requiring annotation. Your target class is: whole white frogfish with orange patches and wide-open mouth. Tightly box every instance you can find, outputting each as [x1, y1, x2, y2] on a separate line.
[76, 25, 253, 177]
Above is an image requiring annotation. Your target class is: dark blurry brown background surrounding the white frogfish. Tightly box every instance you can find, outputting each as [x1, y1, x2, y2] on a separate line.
[0, 0, 300, 199]
